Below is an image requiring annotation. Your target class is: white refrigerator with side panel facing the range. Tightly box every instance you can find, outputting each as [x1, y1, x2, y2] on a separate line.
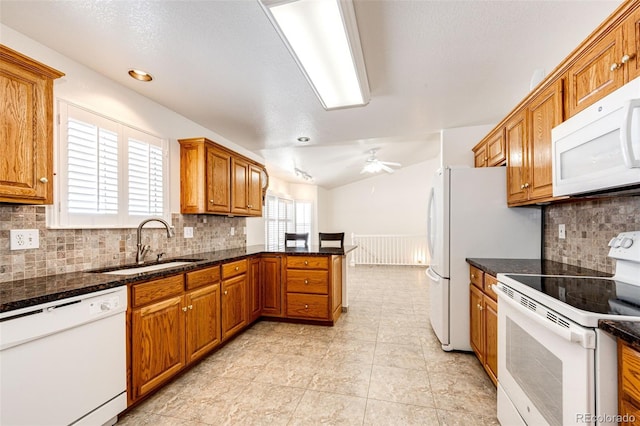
[427, 167, 542, 351]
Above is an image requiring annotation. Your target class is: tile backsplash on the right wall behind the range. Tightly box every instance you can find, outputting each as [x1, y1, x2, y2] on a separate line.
[543, 196, 640, 273]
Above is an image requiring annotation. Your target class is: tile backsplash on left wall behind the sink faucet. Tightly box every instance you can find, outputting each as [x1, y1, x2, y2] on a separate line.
[0, 205, 246, 282]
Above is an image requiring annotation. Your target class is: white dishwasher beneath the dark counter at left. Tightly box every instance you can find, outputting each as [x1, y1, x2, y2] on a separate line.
[0, 286, 127, 426]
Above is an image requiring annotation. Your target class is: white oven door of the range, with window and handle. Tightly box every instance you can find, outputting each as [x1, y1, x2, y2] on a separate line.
[496, 284, 595, 426]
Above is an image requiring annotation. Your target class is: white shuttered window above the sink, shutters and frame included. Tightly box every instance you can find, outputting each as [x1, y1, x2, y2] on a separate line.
[49, 101, 170, 228]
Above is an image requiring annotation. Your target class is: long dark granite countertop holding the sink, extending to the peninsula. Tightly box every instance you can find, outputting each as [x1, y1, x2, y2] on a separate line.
[0, 245, 356, 313]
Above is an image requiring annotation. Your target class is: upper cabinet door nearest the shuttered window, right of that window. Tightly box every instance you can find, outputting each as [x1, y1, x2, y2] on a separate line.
[206, 146, 231, 213]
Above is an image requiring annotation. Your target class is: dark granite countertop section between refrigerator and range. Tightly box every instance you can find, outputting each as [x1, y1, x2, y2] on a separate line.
[467, 258, 611, 277]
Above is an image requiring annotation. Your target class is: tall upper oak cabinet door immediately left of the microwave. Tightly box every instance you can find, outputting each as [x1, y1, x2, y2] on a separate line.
[527, 80, 562, 200]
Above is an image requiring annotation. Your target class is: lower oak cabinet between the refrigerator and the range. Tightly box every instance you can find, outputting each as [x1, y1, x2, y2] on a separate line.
[469, 266, 498, 385]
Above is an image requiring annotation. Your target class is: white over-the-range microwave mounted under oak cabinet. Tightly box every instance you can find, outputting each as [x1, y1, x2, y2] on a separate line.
[551, 77, 640, 196]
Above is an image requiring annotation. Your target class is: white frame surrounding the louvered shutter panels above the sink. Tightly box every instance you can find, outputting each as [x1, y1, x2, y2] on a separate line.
[47, 99, 171, 229]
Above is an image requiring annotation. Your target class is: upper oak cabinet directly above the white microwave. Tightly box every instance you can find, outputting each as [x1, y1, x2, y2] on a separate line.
[566, 1, 640, 118]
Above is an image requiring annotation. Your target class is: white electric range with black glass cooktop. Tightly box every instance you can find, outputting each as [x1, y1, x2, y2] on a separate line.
[494, 231, 640, 426]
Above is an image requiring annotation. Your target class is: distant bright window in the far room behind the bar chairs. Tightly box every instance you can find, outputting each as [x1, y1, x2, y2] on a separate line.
[264, 195, 312, 247]
